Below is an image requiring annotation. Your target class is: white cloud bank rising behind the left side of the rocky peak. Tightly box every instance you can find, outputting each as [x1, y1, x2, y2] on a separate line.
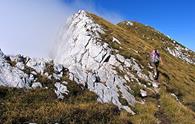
[0, 0, 122, 57]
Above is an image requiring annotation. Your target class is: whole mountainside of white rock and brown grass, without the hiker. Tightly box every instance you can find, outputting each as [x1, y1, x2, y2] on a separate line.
[0, 11, 195, 124]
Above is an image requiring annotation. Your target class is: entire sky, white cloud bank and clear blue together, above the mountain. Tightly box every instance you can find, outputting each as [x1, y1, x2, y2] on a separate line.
[0, 0, 195, 57]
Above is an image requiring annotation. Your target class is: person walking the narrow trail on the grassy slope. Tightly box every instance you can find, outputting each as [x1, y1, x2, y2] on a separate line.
[150, 49, 162, 80]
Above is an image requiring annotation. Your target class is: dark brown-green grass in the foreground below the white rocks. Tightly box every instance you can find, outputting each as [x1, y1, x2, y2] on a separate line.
[0, 75, 131, 124]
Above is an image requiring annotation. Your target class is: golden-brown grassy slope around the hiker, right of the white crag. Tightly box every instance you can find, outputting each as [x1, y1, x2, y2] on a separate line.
[90, 14, 195, 124]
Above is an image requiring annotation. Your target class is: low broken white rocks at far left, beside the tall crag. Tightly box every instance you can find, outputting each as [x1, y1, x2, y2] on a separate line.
[0, 50, 69, 99]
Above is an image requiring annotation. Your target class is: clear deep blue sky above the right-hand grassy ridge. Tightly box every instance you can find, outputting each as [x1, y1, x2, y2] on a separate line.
[90, 0, 195, 51]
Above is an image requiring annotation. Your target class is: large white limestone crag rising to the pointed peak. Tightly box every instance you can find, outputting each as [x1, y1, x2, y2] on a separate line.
[54, 11, 150, 113]
